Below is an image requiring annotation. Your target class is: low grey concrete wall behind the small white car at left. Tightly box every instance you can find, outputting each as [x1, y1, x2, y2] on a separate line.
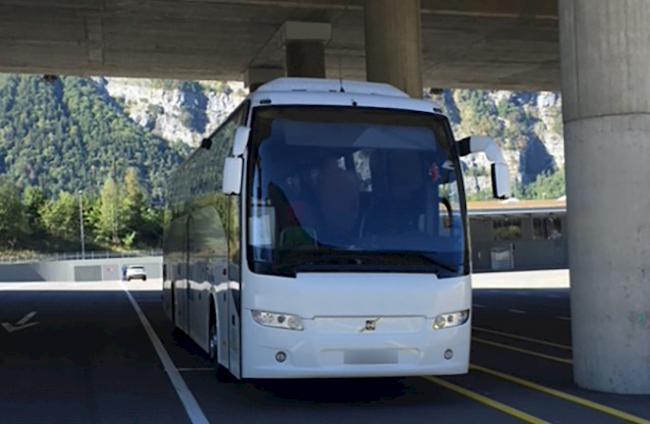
[0, 256, 162, 282]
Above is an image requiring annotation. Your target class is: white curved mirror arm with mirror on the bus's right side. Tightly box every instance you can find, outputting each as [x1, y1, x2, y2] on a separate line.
[458, 136, 510, 199]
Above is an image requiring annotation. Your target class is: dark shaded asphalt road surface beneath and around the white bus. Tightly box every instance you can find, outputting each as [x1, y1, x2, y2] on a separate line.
[0, 283, 650, 424]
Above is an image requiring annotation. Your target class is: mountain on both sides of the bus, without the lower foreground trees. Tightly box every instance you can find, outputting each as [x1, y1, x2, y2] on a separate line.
[0, 75, 564, 200]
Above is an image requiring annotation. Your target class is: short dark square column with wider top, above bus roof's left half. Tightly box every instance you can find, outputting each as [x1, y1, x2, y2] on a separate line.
[282, 22, 332, 78]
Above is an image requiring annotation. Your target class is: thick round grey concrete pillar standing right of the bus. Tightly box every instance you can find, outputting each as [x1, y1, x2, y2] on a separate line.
[559, 0, 650, 393]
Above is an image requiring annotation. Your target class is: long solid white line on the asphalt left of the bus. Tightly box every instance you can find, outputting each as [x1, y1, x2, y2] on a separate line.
[120, 281, 209, 424]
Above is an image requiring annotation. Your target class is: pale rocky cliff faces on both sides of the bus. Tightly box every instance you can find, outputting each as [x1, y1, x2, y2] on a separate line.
[102, 78, 564, 197]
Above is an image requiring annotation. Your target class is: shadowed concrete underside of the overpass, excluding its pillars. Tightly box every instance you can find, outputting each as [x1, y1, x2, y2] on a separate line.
[0, 0, 560, 90]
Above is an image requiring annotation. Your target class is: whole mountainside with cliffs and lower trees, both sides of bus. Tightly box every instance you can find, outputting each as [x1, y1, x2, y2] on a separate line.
[0, 75, 565, 256]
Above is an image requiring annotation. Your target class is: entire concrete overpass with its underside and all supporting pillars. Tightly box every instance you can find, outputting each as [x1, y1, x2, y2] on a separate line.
[0, 0, 650, 393]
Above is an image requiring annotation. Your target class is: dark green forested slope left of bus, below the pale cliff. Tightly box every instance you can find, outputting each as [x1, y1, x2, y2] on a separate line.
[0, 75, 190, 200]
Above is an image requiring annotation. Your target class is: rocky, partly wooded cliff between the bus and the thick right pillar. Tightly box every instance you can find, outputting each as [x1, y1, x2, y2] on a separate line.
[434, 89, 564, 196]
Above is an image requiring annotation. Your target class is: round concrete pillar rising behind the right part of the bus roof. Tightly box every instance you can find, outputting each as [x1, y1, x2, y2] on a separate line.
[364, 0, 422, 98]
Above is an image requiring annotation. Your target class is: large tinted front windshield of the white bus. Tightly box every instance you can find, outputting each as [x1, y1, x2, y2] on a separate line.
[247, 106, 468, 278]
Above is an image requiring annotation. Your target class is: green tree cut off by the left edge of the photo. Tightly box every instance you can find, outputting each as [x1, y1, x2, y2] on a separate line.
[0, 178, 25, 249]
